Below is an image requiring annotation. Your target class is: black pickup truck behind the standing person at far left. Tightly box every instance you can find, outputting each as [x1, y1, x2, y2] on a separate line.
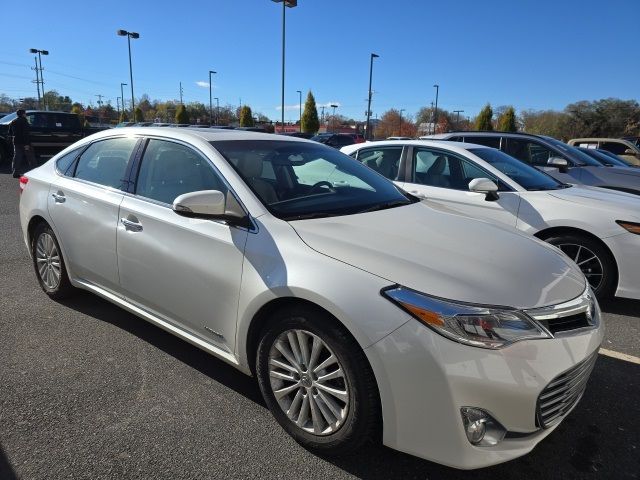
[0, 110, 85, 164]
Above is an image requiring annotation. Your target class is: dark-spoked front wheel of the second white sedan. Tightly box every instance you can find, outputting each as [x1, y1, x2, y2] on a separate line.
[545, 235, 617, 300]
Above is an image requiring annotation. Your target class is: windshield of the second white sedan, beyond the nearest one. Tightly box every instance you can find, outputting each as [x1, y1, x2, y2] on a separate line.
[469, 148, 568, 190]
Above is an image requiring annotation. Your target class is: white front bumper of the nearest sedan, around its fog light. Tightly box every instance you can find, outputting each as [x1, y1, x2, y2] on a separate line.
[365, 319, 604, 469]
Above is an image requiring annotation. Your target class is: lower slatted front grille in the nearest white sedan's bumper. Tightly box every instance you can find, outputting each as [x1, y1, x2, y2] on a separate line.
[536, 350, 598, 428]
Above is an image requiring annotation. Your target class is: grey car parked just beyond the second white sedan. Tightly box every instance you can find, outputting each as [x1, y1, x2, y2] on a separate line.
[420, 132, 640, 195]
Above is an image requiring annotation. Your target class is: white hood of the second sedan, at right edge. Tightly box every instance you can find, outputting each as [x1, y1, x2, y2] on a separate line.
[549, 185, 640, 220]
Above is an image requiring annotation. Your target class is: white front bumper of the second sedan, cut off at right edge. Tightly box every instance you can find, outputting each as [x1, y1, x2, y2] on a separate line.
[602, 232, 640, 300]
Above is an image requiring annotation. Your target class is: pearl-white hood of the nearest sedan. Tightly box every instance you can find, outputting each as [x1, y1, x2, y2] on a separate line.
[290, 202, 586, 308]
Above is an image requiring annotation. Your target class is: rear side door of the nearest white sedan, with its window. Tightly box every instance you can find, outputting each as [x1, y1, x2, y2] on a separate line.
[48, 137, 138, 293]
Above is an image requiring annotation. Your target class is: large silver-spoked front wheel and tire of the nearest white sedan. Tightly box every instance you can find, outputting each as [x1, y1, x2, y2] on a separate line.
[256, 306, 381, 455]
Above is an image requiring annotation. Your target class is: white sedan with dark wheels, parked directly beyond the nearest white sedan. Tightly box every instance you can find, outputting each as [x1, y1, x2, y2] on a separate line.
[342, 141, 640, 299]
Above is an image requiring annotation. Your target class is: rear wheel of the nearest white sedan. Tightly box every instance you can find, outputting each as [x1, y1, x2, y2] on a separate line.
[31, 223, 75, 300]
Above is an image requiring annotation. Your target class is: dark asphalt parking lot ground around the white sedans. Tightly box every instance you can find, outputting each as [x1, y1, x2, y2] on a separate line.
[0, 165, 640, 480]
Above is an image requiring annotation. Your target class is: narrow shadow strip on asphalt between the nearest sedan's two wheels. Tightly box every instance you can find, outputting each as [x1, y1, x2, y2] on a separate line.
[59, 291, 266, 406]
